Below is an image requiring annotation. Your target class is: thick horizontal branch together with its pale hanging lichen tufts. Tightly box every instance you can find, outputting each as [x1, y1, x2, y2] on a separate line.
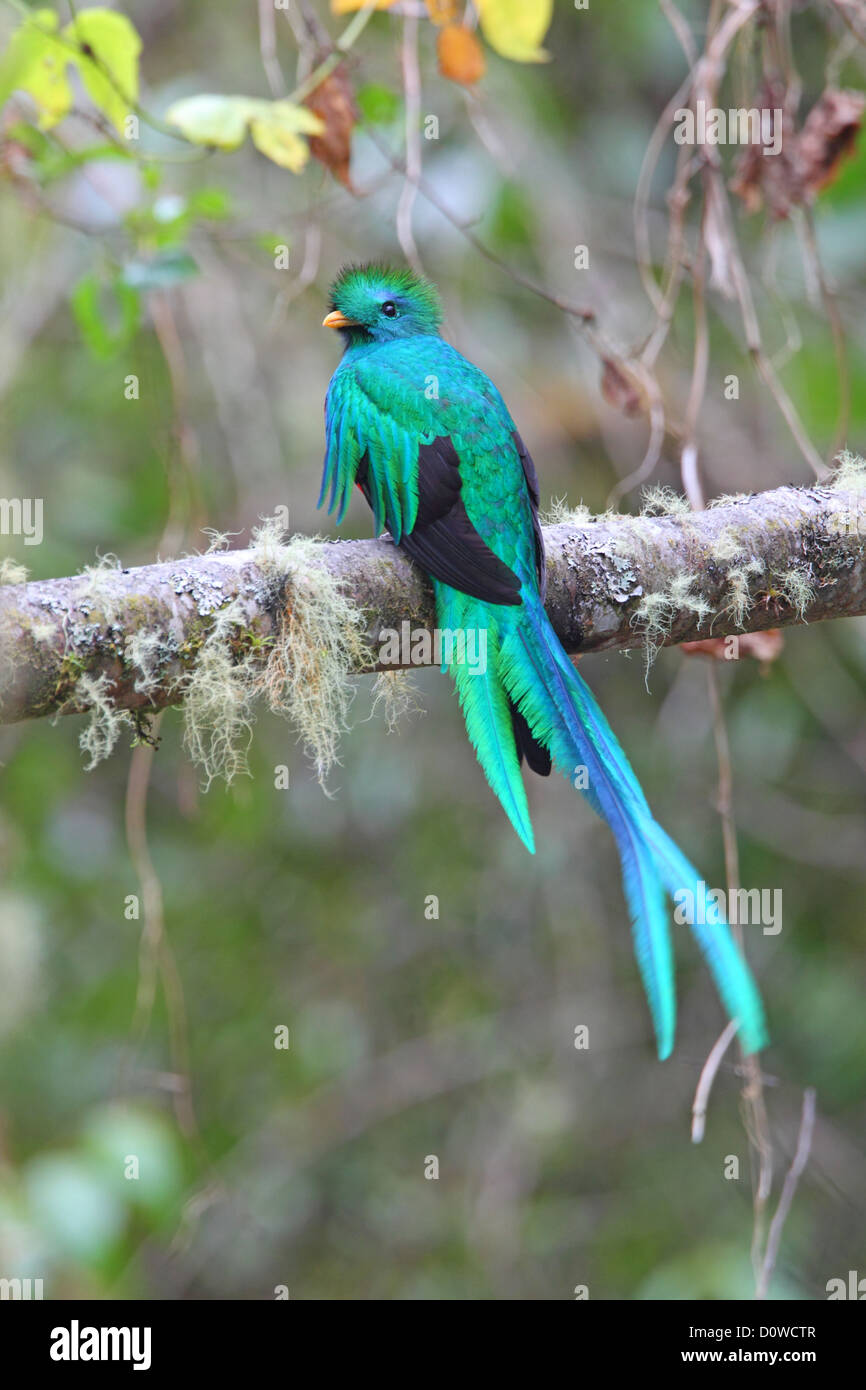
[0, 469, 866, 781]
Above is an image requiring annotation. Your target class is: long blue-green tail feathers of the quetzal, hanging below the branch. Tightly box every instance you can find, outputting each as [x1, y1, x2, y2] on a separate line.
[450, 588, 766, 1058]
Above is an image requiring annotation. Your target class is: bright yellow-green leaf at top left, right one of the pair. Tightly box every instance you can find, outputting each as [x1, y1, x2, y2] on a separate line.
[63, 10, 142, 135]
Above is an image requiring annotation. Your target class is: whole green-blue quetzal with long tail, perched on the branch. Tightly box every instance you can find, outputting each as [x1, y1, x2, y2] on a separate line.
[318, 265, 766, 1058]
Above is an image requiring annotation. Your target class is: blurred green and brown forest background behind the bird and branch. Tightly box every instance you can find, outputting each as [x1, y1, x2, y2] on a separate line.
[0, 0, 866, 1300]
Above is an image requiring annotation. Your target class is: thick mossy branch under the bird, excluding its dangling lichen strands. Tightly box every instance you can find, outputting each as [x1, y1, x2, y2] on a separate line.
[0, 478, 866, 723]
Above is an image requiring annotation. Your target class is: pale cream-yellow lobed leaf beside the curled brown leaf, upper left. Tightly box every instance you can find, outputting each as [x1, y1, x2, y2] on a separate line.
[165, 95, 324, 174]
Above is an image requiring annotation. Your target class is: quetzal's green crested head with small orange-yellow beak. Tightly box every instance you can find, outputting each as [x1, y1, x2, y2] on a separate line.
[324, 265, 442, 345]
